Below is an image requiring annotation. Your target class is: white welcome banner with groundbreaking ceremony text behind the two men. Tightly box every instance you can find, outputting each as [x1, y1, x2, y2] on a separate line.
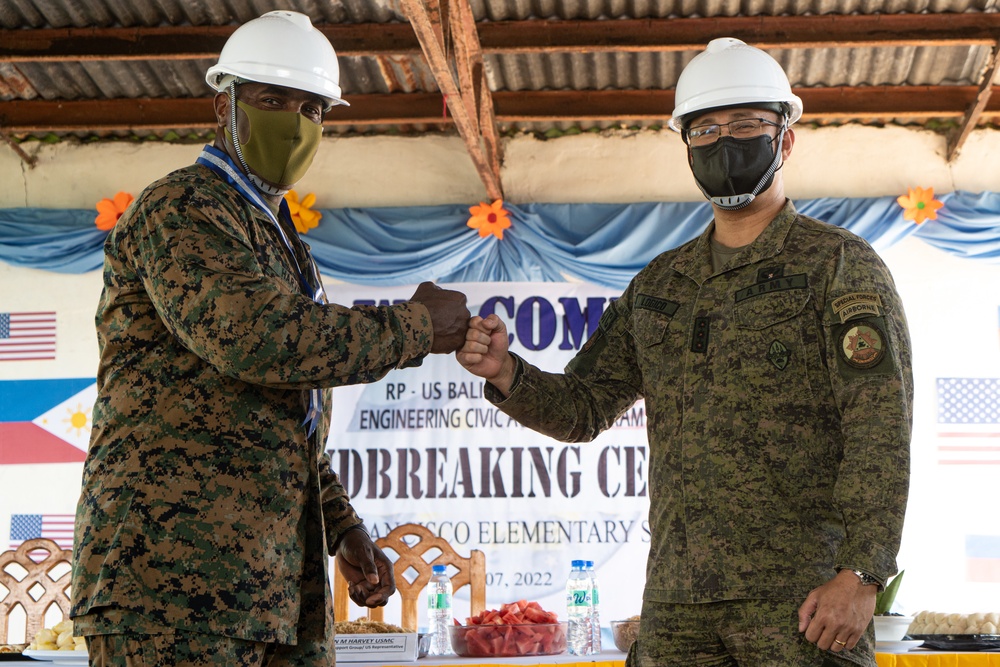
[327, 283, 649, 625]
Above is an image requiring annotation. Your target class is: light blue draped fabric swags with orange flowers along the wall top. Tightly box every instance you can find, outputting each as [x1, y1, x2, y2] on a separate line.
[0, 191, 1000, 289]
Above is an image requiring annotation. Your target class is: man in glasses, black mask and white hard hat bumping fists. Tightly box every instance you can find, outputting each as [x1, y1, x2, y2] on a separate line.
[458, 39, 912, 667]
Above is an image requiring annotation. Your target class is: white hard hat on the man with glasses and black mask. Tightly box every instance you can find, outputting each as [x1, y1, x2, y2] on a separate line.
[668, 37, 802, 132]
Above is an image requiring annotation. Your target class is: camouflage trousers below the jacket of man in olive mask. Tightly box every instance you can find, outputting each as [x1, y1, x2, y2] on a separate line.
[87, 630, 337, 667]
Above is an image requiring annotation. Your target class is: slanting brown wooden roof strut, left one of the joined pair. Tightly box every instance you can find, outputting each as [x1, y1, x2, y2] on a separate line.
[400, 0, 503, 199]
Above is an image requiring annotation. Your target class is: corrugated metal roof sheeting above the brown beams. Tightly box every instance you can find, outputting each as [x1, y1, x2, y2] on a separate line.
[0, 0, 1000, 144]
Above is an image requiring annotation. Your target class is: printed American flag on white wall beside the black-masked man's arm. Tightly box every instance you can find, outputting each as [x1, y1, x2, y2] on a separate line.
[937, 378, 1000, 466]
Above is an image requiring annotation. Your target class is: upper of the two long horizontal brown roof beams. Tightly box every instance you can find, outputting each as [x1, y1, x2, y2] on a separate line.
[0, 12, 1000, 62]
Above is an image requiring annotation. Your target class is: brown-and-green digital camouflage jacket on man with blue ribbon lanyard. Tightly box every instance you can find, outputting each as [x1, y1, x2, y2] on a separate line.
[72, 159, 432, 643]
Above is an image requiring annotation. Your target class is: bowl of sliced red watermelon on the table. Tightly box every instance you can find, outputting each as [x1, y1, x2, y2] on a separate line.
[448, 600, 566, 658]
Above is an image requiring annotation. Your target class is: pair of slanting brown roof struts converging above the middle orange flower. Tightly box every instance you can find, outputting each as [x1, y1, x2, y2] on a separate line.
[401, 0, 503, 199]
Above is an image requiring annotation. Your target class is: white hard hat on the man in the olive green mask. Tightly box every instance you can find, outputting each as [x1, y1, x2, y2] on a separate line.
[205, 10, 349, 109]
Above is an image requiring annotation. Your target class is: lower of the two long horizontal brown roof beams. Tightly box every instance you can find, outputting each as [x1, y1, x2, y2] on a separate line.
[0, 86, 1000, 135]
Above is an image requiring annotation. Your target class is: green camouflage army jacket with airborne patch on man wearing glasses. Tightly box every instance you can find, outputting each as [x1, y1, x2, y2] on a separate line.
[487, 202, 913, 603]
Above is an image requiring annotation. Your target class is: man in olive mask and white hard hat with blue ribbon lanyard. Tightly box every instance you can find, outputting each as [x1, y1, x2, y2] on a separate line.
[72, 11, 469, 667]
